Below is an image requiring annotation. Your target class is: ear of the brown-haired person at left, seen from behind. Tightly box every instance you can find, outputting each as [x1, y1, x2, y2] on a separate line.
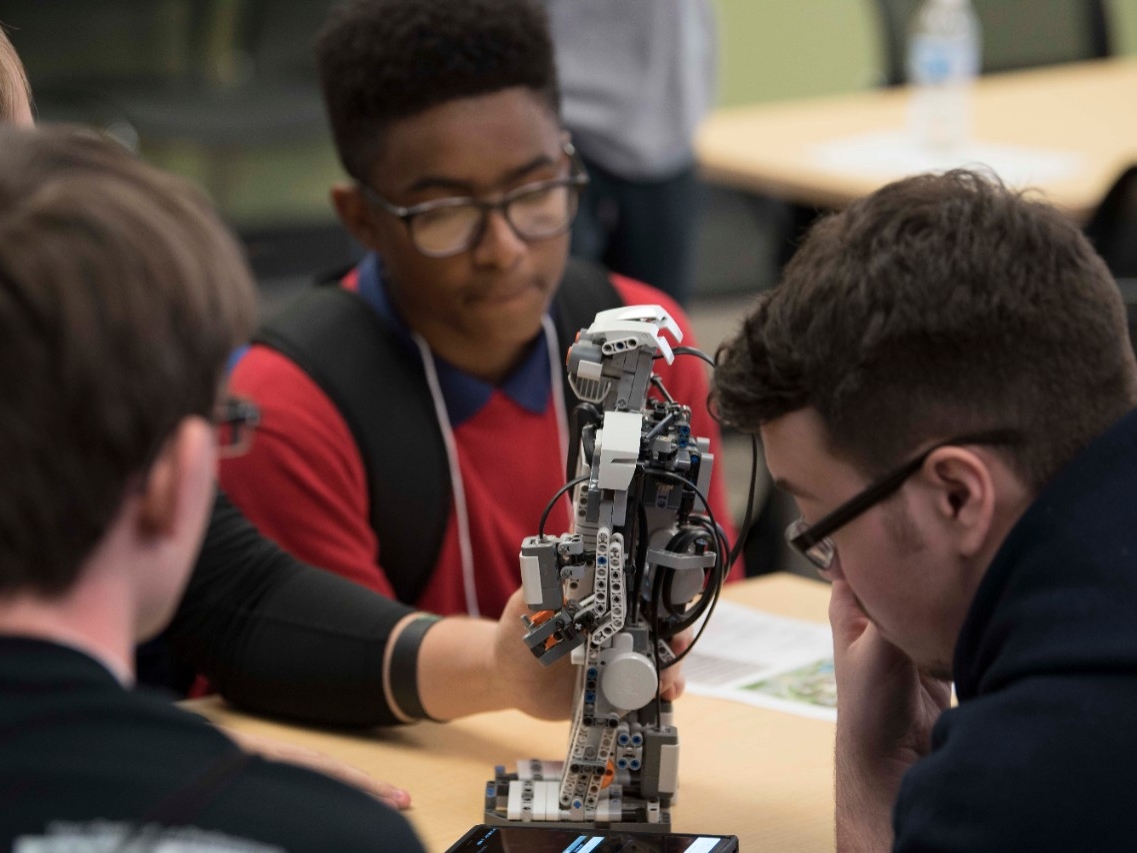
[138, 416, 217, 538]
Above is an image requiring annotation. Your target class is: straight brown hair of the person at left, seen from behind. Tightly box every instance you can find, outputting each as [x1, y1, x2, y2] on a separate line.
[0, 125, 254, 597]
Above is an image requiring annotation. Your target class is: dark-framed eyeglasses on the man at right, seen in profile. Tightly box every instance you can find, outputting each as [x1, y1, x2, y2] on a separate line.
[786, 430, 1022, 571]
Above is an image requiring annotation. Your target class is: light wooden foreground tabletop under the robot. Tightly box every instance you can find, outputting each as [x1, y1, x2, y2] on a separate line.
[185, 574, 833, 853]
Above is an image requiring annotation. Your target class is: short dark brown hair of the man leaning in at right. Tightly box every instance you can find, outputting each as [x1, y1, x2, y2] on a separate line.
[715, 171, 1137, 490]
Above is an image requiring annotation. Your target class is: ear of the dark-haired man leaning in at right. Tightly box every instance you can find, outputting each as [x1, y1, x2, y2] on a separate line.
[920, 447, 996, 557]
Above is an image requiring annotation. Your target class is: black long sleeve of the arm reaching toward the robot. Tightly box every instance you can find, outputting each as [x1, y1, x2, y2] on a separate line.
[166, 494, 414, 726]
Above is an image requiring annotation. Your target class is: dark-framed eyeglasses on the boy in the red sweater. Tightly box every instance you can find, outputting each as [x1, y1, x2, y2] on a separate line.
[359, 143, 588, 258]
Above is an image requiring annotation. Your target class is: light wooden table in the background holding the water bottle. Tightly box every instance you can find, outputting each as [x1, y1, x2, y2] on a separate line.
[696, 57, 1137, 221]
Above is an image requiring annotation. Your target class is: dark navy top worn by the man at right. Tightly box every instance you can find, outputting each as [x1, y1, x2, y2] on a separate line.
[893, 411, 1137, 851]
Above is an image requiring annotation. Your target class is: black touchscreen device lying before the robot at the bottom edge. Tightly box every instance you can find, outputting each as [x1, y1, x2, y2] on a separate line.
[446, 823, 738, 853]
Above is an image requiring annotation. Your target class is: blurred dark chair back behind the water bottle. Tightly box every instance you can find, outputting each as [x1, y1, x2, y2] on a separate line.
[875, 0, 1111, 85]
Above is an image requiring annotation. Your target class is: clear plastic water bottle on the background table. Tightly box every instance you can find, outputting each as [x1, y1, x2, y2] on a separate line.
[907, 0, 982, 152]
